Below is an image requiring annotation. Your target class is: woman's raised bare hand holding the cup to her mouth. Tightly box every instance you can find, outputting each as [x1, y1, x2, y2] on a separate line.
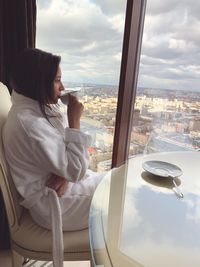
[67, 94, 84, 129]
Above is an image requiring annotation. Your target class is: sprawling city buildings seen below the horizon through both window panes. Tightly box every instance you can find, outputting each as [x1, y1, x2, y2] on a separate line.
[63, 83, 200, 172]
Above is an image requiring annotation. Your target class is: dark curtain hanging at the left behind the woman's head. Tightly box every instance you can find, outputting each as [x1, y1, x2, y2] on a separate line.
[0, 0, 36, 249]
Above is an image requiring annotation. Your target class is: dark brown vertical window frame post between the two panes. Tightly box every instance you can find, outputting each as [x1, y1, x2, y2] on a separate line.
[112, 0, 146, 168]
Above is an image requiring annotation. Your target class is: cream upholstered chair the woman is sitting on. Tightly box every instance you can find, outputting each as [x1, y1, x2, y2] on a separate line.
[0, 82, 91, 267]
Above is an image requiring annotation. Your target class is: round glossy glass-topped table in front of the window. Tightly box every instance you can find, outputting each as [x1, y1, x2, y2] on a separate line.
[89, 151, 200, 267]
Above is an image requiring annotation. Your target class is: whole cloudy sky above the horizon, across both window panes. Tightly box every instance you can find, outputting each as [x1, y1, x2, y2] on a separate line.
[36, 0, 200, 92]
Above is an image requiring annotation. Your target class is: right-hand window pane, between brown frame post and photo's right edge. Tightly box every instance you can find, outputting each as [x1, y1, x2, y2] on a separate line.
[129, 0, 200, 156]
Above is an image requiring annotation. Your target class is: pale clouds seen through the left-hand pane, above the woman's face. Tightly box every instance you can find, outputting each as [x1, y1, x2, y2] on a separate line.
[37, 0, 124, 84]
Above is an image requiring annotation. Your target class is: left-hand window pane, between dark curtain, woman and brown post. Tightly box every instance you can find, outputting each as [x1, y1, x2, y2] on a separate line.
[36, 0, 126, 171]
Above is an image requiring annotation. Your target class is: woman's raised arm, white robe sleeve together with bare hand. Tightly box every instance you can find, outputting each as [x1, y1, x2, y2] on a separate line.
[18, 96, 92, 182]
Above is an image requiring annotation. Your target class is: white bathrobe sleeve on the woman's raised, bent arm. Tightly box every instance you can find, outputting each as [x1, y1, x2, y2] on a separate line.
[23, 118, 91, 182]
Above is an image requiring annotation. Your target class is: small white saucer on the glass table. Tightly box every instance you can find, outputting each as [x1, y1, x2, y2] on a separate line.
[142, 160, 183, 178]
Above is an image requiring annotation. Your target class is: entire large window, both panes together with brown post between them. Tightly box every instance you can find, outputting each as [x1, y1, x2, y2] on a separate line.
[37, 0, 200, 171]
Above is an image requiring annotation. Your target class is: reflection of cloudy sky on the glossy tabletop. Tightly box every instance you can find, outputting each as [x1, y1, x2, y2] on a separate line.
[120, 152, 200, 267]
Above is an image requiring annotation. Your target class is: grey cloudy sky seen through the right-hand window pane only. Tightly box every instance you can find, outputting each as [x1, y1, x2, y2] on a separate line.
[139, 0, 200, 90]
